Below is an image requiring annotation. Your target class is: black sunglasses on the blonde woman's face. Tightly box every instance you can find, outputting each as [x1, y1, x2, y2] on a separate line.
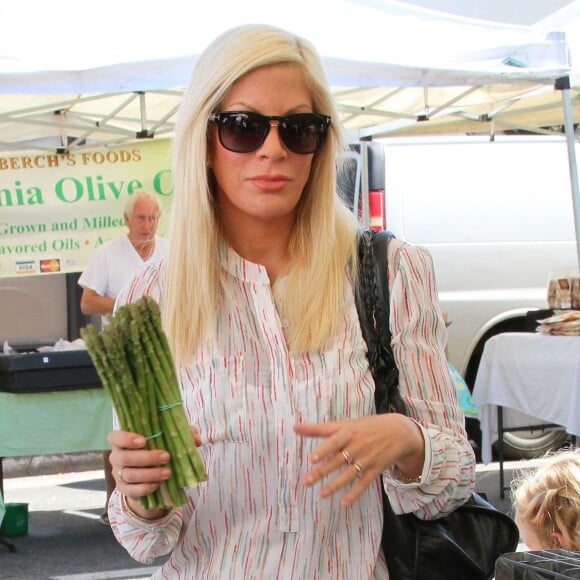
[209, 111, 330, 155]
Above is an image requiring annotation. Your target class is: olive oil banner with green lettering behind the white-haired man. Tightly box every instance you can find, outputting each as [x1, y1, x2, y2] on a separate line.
[0, 139, 172, 277]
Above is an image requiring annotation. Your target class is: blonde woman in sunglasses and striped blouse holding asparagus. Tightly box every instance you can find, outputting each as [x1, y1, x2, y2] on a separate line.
[109, 25, 475, 579]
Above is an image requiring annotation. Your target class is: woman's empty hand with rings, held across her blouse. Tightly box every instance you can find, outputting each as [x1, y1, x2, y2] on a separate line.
[294, 413, 425, 507]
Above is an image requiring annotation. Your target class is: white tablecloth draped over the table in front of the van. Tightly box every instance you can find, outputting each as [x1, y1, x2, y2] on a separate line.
[472, 332, 580, 463]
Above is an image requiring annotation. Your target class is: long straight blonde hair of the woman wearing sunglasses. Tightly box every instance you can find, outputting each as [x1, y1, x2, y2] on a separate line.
[163, 25, 357, 365]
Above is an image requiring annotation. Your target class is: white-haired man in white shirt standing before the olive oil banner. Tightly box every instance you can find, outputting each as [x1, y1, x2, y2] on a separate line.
[78, 192, 168, 524]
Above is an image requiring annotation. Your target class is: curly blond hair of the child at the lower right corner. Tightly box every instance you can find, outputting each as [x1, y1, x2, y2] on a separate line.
[511, 450, 580, 550]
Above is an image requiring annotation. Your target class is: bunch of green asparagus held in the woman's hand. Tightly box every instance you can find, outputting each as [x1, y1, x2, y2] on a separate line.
[81, 296, 207, 508]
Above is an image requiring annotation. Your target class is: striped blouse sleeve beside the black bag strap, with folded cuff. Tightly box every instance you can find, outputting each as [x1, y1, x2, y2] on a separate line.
[384, 240, 475, 519]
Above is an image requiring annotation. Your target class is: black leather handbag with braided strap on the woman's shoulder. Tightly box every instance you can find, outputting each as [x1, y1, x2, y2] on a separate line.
[356, 231, 519, 580]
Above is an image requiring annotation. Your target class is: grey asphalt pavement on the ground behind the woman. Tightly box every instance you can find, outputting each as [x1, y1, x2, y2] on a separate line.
[0, 453, 537, 580]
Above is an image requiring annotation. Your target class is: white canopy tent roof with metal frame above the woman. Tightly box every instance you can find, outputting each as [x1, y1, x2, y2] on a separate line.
[0, 0, 580, 262]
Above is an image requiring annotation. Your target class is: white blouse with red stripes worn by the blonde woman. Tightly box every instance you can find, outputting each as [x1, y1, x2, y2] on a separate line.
[109, 240, 475, 580]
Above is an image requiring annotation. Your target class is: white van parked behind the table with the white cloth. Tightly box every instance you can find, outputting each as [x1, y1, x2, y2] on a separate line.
[358, 136, 580, 456]
